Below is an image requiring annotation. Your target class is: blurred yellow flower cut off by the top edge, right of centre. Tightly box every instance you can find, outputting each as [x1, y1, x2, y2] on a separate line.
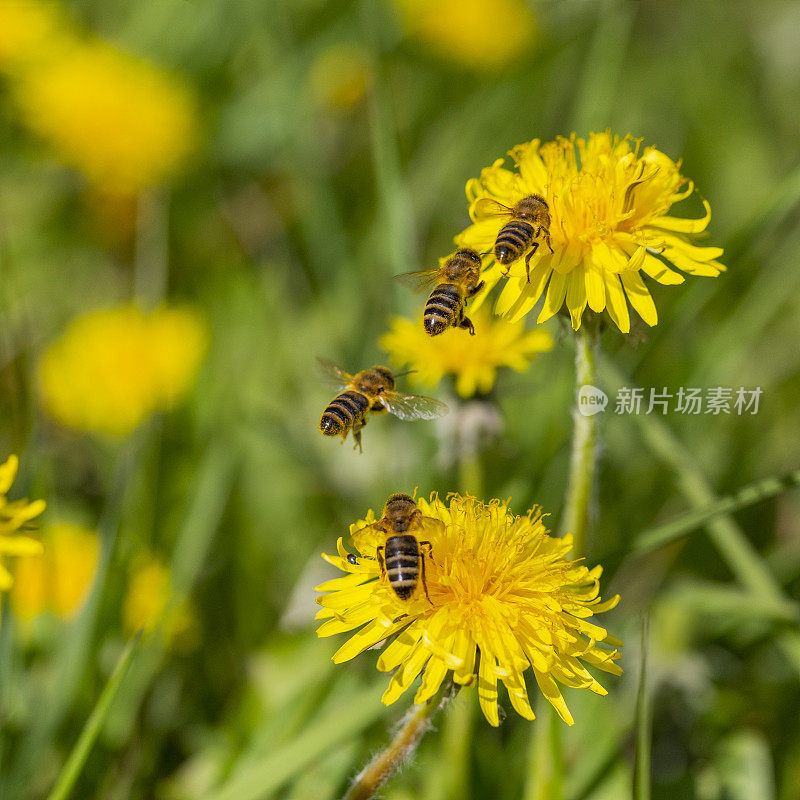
[394, 0, 537, 70]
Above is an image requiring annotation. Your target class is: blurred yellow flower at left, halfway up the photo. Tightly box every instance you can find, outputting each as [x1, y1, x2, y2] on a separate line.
[39, 306, 208, 436]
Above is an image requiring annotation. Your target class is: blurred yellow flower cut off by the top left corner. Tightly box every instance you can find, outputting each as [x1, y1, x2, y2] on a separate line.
[0, 0, 73, 75]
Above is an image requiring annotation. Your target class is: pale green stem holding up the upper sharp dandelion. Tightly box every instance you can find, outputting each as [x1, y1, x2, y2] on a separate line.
[561, 320, 599, 558]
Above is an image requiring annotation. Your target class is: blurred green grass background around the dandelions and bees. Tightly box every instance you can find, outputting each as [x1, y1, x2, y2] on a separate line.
[0, 0, 800, 800]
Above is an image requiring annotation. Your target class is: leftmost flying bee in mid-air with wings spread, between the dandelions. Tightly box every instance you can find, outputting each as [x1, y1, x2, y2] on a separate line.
[319, 359, 447, 452]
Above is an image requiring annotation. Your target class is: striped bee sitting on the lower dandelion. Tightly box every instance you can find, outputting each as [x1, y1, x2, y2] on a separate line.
[351, 493, 444, 603]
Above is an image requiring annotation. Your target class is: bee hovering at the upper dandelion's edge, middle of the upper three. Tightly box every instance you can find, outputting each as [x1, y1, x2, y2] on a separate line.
[397, 248, 485, 336]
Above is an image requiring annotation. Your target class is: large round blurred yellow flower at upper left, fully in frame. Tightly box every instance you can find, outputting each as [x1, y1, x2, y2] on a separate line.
[15, 41, 197, 195]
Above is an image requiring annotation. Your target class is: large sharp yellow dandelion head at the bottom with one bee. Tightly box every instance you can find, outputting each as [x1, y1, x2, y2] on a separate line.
[317, 493, 621, 725]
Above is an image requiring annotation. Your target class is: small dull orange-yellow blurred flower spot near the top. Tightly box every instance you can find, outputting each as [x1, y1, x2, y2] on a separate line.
[309, 44, 371, 111]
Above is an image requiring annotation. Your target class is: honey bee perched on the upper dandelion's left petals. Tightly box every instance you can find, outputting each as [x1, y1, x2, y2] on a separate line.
[475, 194, 554, 283]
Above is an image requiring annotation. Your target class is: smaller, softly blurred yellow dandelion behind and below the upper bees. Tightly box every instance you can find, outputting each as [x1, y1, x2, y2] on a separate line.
[380, 310, 553, 398]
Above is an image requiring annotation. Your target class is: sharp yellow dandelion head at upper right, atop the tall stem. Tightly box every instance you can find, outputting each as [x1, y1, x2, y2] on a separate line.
[456, 132, 725, 333]
